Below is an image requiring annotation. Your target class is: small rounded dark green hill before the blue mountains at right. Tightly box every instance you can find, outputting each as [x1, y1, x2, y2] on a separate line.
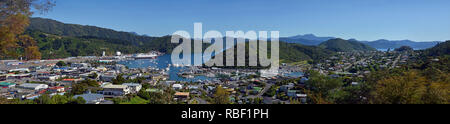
[319, 38, 376, 52]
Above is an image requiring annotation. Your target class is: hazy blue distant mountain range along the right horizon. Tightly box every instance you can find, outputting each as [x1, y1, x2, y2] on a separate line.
[280, 34, 440, 49]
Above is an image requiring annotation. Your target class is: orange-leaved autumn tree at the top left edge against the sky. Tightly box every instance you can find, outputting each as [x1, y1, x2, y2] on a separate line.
[0, 0, 54, 60]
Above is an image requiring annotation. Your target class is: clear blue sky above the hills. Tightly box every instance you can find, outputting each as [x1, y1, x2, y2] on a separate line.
[34, 0, 450, 41]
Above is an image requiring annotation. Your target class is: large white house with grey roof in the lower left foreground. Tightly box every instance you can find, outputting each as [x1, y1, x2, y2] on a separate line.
[99, 85, 130, 96]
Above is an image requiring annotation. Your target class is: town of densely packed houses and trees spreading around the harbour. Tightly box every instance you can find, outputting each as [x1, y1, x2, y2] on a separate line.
[0, 48, 417, 104]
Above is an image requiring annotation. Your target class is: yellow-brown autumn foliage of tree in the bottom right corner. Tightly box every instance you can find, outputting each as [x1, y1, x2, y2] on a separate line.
[373, 70, 449, 104]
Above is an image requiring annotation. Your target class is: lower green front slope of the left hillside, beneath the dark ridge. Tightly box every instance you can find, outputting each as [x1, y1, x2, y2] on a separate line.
[26, 30, 177, 59]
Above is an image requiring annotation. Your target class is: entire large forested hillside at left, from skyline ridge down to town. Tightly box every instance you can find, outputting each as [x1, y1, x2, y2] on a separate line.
[25, 18, 184, 59]
